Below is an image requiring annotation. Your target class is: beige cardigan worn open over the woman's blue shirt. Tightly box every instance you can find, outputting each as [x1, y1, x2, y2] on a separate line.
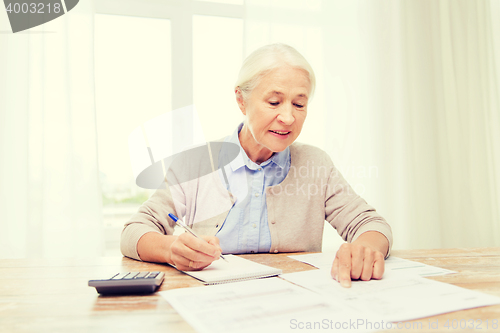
[121, 143, 392, 260]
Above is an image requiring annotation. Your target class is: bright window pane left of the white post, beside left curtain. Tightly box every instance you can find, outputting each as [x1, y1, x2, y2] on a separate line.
[95, 15, 172, 254]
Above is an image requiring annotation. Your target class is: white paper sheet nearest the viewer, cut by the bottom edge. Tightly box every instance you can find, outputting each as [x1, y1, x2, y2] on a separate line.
[160, 278, 381, 333]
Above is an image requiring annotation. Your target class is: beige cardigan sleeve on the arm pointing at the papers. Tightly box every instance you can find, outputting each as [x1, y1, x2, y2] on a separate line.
[325, 166, 392, 258]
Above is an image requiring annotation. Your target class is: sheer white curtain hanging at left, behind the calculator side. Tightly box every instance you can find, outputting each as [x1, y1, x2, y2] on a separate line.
[0, 0, 103, 258]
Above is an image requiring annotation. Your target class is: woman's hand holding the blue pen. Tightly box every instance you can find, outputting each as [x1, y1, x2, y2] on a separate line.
[170, 232, 222, 271]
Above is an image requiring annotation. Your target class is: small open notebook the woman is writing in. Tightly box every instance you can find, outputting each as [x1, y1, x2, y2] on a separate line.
[183, 254, 283, 284]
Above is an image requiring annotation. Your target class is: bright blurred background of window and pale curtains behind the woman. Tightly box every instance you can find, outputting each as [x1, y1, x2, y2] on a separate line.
[0, 0, 500, 258]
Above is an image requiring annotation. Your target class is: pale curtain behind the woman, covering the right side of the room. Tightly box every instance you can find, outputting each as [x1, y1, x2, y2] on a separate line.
[245, 0, 500, 249]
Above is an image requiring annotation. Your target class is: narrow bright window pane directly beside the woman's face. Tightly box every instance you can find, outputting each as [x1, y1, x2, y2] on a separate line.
[193, 15, 243, 141]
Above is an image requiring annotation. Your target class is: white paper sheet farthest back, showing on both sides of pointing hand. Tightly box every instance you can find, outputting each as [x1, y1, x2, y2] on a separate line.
[289, 252, 456, 276]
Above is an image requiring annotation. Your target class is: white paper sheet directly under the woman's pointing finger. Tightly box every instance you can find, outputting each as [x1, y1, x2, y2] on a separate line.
[281, 269, 500, 322]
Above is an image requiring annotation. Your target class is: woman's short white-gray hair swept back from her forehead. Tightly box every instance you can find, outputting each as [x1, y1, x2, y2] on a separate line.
[235, 43, 316, 99]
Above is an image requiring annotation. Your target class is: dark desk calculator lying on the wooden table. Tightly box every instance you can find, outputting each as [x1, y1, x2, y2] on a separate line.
[89, 272, 165, 295]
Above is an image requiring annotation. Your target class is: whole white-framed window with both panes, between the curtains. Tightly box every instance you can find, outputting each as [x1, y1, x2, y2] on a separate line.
[95, 0, 243, 255]
